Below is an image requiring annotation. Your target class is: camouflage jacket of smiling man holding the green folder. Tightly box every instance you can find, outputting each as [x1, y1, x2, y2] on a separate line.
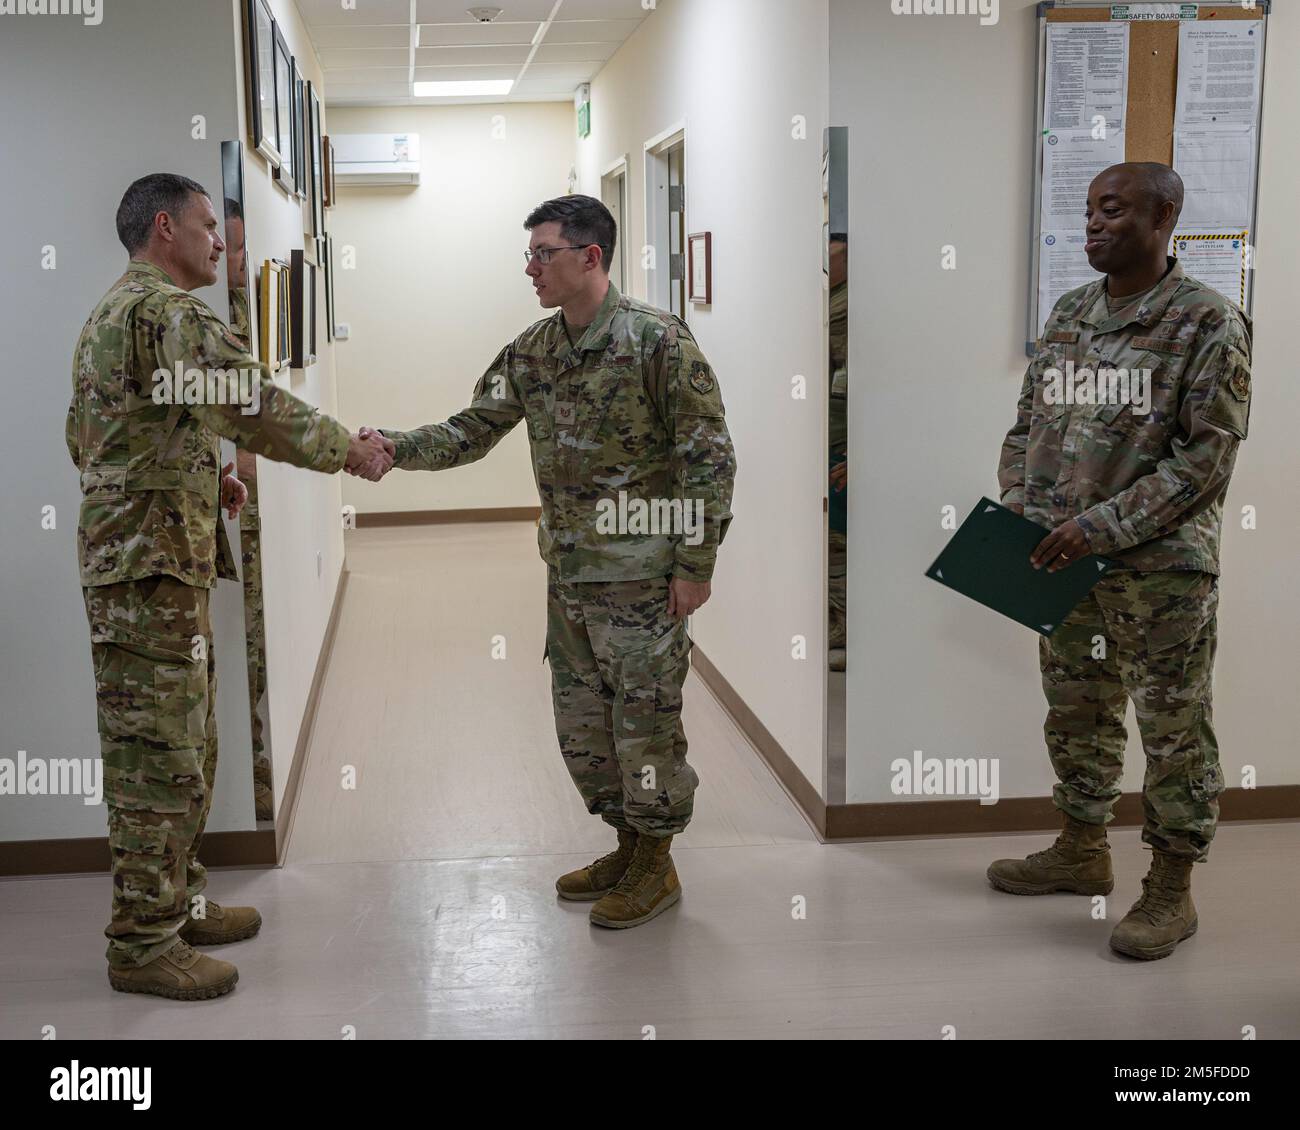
[997, 263, 1251, 573]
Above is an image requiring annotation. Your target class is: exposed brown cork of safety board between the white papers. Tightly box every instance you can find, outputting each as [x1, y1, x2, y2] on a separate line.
[1047, 5, 1264, 165]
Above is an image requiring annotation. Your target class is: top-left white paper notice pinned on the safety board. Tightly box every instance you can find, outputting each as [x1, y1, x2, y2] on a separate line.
[1043, 23, 1128, 131]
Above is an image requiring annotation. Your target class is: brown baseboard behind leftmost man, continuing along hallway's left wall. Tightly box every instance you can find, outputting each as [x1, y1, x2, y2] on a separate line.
[0, 563, 347, 879]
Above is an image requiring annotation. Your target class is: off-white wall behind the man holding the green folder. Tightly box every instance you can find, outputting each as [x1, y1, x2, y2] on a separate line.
[831, 0, 1300, 802]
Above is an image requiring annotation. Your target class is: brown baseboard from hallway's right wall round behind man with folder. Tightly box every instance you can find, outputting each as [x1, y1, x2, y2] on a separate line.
[692, 644, 1300, 843]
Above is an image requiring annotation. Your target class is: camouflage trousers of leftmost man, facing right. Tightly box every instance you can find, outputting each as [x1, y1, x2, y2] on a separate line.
[83, 576, 217, 966]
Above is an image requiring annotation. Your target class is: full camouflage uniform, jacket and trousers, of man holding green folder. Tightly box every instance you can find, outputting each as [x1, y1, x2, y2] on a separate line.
[998, 263, 1251, 860]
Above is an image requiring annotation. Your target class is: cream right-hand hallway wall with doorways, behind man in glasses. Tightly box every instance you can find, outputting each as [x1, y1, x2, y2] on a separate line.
[579, 0, 827, 791]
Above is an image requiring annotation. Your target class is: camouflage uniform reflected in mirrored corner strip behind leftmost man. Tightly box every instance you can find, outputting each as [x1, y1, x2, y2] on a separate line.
[230, 286, 274, 821]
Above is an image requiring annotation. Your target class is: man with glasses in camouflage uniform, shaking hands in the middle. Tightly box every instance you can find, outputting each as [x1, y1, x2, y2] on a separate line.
[363, 196, 736, 928]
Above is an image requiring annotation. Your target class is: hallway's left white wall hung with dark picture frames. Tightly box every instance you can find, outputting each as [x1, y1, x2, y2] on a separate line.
[229, 0, 358, 811]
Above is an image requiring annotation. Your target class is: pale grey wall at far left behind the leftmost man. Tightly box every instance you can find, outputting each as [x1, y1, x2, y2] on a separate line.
[0, 0, 254, 840]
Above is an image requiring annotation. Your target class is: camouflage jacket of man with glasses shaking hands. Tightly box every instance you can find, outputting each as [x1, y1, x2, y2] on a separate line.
[384, 283, 736, 581]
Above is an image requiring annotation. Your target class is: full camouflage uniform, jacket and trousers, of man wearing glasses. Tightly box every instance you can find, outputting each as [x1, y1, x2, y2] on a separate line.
[385, 285, 735, 836]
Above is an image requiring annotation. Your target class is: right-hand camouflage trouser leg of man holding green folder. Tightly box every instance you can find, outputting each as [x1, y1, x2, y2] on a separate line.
[1134, 573, 1225, 860]
